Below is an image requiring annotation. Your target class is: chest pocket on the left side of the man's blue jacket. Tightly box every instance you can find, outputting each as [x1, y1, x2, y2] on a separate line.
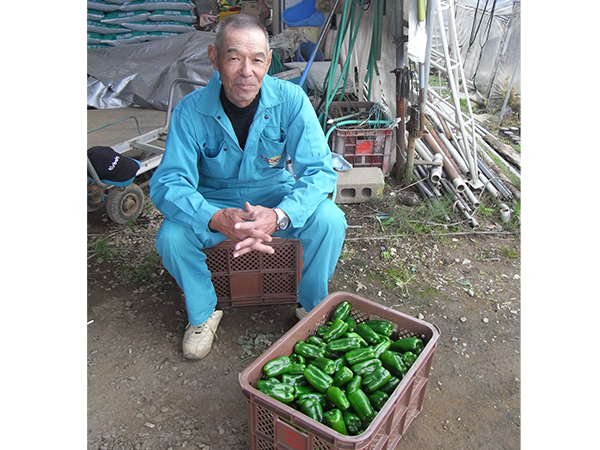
[198, 138, 242, 179]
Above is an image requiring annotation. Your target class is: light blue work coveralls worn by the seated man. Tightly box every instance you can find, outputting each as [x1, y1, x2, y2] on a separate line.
[150, 72, 346, 325]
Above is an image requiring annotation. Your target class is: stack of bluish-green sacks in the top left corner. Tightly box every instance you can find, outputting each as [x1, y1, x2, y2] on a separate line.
[87, 0, 197, 49]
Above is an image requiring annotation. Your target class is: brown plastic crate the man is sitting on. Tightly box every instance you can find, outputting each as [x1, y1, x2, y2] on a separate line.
[204, 237, 302, 307]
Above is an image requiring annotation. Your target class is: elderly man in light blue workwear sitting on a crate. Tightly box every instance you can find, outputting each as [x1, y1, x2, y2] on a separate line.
[150, 14, 346, 359]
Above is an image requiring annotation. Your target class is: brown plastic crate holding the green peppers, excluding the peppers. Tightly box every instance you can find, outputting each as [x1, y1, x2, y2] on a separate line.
[239, 292, 440, 450]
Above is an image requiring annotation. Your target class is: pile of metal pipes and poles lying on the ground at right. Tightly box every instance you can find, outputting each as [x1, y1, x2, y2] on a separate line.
[400, 87, 521, 228]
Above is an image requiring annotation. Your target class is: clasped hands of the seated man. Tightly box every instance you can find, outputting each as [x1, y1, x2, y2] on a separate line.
[208, 202, 277, 258]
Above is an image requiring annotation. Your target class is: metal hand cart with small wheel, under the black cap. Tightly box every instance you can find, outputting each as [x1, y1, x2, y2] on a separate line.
[87, 78, 206, 224]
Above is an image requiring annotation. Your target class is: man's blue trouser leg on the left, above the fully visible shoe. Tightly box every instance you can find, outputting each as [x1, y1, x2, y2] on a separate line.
[156, 219, 225, 325]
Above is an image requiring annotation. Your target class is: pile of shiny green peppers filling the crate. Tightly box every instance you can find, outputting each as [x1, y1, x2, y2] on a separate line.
[257, 301, 424, 436]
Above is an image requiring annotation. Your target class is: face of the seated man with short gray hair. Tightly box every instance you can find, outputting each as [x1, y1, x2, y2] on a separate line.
[208, 28, 272, 108]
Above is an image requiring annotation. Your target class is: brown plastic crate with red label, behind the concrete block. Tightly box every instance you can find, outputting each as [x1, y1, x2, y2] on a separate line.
[331, 128, 394, 176]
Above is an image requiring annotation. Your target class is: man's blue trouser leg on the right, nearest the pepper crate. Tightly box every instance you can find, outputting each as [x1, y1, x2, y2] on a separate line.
[275, 200, 346, 311]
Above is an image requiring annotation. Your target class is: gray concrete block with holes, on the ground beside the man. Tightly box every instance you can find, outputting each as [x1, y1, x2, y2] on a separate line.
[335, 167, 384, 204]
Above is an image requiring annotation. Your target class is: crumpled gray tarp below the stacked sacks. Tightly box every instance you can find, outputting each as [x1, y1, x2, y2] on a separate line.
[87, 31, 215, 111]
